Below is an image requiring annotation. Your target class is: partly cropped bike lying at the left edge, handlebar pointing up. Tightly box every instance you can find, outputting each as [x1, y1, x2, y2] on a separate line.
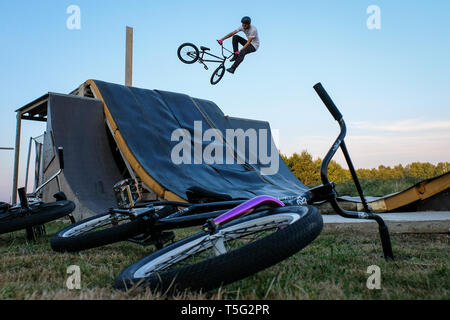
[0, 148, 75, 240]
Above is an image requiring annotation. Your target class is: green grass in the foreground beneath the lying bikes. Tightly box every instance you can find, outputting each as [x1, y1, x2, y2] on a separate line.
[0, 223, 450, 300]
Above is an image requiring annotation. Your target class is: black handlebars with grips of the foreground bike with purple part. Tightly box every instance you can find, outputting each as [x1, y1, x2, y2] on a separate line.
[314, 83, 394, 260]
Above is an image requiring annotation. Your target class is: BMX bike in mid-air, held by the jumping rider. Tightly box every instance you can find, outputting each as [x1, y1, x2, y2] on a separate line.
[177, 43, 234, 85]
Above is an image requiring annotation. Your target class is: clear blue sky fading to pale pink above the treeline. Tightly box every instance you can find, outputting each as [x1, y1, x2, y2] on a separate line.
[0, 0, 450, 201]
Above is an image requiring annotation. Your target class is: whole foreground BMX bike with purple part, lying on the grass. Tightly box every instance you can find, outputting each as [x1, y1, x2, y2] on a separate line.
[51, 83, 394, 292]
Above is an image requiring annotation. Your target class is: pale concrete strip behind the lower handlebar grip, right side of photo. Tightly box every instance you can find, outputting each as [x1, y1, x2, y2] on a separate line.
[323, 211, 450, 233]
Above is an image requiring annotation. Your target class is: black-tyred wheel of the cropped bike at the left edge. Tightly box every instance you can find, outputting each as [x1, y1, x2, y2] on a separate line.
[0, 200, 75, 234]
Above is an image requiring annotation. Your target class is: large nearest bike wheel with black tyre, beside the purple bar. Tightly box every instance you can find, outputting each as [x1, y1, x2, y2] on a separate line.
[115, 206, 323, 292]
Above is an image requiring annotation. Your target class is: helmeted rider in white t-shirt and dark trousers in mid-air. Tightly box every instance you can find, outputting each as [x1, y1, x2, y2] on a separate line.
[218, 17, 259, 73]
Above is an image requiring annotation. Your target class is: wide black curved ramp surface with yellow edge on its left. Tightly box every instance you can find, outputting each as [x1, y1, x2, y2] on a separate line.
[94, 80, 307, 199]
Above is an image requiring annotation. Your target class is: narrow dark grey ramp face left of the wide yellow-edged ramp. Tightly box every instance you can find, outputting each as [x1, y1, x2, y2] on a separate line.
[48, 95, 122, 213]
